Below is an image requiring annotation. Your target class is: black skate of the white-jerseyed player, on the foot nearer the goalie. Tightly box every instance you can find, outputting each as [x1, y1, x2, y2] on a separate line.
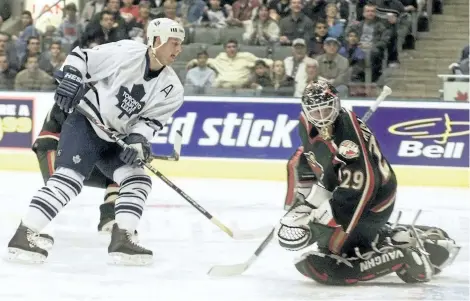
[108, 224, 153, 265]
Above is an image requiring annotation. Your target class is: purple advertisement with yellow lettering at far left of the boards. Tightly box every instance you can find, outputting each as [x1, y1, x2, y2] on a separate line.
[0, 97, 34, 149]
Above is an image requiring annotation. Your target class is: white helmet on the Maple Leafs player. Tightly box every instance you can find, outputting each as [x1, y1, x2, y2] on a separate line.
[147, 18, 185, 48]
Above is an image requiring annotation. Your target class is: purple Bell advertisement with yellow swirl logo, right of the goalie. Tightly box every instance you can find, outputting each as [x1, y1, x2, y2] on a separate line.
[353, 107, 470, 167]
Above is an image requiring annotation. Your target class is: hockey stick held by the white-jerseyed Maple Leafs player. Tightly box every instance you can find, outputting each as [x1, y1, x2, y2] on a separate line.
[76, 106, 267, 240]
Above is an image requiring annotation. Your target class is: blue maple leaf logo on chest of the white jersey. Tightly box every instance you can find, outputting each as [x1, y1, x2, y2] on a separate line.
[116, 85, 145, 118]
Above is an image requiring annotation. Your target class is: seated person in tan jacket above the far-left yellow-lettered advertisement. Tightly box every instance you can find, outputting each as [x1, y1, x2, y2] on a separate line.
[15, 56, 55, 91]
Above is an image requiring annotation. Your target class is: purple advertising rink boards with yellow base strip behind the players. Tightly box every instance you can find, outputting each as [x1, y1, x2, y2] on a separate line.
[0, 92, 470, 187]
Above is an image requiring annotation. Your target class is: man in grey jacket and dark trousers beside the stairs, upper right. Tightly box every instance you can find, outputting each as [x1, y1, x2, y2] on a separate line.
[350, 4, 390, 82]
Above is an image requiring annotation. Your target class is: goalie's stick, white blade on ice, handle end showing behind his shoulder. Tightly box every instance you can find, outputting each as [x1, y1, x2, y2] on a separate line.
[208, 86, 392, 277]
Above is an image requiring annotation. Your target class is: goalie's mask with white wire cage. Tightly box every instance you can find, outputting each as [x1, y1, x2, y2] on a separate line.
[302, 80, 341, 128]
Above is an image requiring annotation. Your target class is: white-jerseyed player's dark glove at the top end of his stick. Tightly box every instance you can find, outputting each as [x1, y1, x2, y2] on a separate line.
[54, 65, 84, 113]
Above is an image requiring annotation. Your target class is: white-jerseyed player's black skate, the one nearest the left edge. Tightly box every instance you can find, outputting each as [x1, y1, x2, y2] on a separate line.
[7, 224, 48, 263]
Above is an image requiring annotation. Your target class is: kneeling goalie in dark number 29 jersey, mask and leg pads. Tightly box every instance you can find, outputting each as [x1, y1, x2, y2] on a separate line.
[277, 81, 459, 285]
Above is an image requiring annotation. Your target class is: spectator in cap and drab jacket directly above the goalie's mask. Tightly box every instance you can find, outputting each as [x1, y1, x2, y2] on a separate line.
[317, 37, 350, 97]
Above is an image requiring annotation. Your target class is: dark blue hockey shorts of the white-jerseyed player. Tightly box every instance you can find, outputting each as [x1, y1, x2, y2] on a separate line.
[55, 112, 124, 179]
